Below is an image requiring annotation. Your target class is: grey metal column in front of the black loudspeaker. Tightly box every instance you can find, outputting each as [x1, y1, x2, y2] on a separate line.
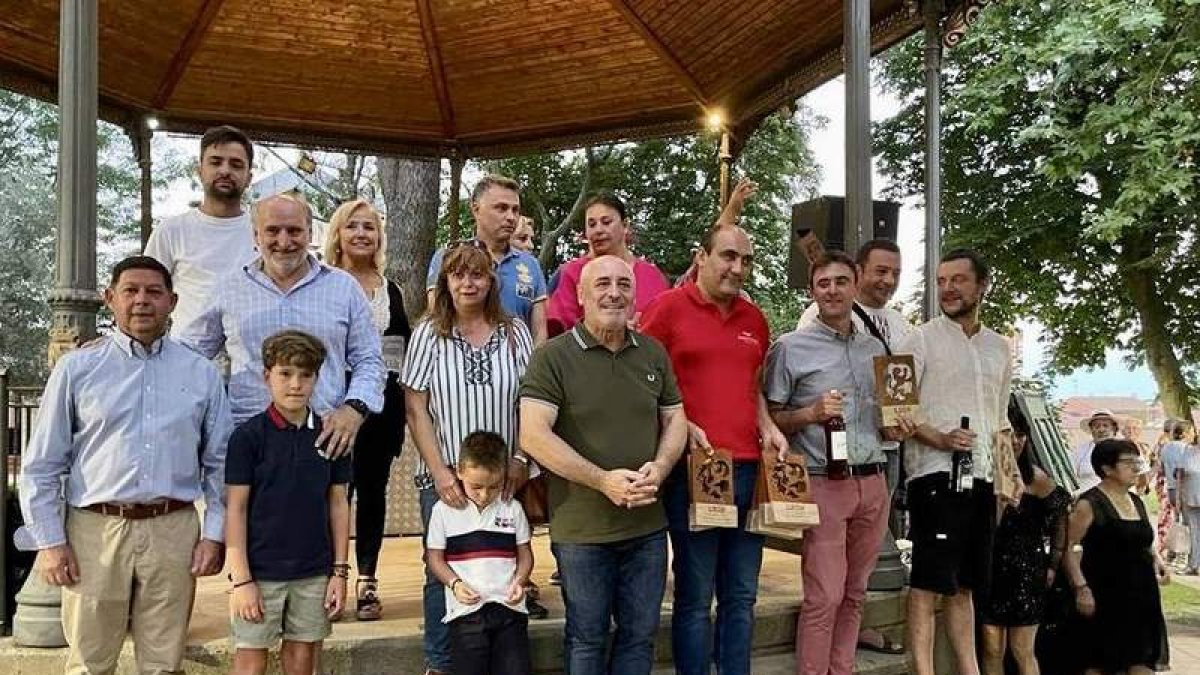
[842, 0, 875, 256]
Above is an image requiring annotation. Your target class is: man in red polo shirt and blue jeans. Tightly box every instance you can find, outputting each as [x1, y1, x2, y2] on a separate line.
[641, 226, 787, 675]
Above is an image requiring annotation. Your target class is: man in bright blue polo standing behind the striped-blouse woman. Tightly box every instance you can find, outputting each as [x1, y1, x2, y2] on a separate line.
[425, 175, 547, 345]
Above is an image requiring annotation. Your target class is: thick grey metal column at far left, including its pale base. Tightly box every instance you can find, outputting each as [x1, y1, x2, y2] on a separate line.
[13, 0, 101, 647]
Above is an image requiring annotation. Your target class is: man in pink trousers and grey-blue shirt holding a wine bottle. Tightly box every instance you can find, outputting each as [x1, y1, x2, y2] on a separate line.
[763, 251, 888, 675]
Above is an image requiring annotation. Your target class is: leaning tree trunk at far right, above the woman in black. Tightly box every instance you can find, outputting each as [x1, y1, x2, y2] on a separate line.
[1118, 229, 1192, 419]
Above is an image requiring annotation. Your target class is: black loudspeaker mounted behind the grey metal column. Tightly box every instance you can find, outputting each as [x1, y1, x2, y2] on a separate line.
[787, 196, 900, 288]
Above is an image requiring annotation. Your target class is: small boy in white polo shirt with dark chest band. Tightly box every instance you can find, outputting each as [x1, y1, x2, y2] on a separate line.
[425, 431, 533, 675]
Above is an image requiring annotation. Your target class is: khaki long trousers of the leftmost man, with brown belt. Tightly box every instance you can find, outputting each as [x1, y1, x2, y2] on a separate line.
[62, 508, 200, 675]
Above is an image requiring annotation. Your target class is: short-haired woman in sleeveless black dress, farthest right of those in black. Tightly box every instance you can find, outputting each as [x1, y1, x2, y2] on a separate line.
[1066, 438, 1170, 675]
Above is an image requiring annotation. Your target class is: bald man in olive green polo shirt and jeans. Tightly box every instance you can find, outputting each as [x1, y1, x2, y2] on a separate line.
[521, 256, 688, 675]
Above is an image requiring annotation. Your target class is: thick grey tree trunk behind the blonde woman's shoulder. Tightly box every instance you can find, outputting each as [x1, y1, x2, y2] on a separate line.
[378, 157, 442, 322]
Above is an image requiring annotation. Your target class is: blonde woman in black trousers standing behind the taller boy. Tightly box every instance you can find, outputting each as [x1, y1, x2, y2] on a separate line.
[322, 199, 412, 621]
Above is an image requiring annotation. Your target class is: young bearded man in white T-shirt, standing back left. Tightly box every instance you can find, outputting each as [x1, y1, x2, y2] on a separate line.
[145, 126, 254, 338]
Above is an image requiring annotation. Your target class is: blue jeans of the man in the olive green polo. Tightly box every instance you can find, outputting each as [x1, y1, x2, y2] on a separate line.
[551, 531, 667, 675]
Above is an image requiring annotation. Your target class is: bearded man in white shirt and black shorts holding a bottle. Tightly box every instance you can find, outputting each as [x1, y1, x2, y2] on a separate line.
[896, 249, 1013, 675]
